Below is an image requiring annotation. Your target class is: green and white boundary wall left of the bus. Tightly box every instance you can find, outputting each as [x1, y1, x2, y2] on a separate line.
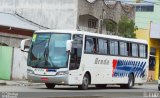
[0, 46, 27, 80]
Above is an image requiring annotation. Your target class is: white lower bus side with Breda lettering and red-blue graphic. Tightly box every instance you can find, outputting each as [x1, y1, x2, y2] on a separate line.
[81, 54, 148, 84]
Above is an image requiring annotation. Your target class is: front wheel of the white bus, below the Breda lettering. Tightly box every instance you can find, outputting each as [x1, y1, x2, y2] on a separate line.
[78, 74, 90, 90]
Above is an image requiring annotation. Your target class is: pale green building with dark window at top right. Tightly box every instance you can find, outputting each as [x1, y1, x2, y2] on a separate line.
[121, 0, 160, 29]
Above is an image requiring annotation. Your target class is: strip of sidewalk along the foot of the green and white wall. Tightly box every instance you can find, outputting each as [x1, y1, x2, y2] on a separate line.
[0, 80, 44, 86]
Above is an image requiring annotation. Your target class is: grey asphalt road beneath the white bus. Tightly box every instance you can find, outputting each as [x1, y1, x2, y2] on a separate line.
[0, 84, 160, 98]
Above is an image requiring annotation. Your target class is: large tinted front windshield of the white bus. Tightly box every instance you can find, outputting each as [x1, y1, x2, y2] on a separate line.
[27, 33, 71, 69]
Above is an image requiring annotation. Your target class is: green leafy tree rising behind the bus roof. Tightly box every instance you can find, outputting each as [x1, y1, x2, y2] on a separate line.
[118, 16, 138, 38]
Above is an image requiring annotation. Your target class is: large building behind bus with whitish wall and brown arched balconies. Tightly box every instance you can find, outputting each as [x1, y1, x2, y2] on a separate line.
[0, 0, 135, 33]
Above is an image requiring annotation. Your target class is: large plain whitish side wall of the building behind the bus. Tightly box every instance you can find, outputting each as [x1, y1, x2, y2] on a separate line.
[0, 0, 77, 29]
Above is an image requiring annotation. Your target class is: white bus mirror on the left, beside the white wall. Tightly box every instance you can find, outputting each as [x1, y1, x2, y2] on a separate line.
[20, 39, 31, 52]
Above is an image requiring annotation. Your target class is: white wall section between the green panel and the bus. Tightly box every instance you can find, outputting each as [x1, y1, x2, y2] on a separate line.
[12, 48, 27, 80]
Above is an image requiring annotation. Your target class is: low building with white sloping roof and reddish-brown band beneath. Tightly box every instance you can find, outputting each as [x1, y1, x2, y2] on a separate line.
[0, 12, 46, 47]
